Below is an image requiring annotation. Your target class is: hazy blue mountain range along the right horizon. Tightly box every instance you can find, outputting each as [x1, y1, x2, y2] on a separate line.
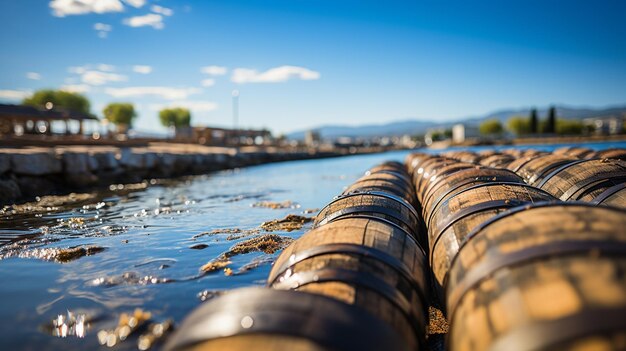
[287, 106, 626, 140]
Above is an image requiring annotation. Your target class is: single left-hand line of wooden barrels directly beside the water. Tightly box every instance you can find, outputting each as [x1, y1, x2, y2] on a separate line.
[166, 162, 431, 350]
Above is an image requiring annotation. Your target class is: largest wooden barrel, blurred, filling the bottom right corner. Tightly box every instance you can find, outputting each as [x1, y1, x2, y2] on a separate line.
[447, 203, 626, 351]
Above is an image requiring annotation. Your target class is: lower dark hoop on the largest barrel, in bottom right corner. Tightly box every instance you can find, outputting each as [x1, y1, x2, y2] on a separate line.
[489, 307, 626, 351]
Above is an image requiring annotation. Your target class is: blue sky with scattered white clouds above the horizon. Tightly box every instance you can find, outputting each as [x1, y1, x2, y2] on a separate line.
[0, 0, 626, 133]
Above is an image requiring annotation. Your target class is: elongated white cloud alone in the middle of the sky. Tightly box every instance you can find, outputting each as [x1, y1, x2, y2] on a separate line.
[230, 66, 320, 84]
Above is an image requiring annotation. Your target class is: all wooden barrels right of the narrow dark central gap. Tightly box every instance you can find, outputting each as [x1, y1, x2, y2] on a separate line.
[405, 150, 626, 350]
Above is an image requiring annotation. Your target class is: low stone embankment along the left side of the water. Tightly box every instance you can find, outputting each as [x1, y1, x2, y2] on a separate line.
[0, 143, 384, 205]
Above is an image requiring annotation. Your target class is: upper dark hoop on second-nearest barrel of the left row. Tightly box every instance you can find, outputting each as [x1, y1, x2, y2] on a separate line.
[268, 243, 427, 301]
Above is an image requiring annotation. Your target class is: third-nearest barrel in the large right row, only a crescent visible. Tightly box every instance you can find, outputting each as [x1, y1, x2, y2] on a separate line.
[422, 167, 524, 227]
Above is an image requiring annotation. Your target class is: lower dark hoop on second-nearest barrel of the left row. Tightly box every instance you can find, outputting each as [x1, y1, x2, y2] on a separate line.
[273, 268, 427, 338]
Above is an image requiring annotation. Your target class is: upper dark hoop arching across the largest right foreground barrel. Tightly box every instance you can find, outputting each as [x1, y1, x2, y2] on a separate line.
[445, 240, 626, 321]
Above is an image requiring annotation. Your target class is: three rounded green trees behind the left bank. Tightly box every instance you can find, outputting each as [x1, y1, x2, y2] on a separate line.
[22, 89, 191, 128]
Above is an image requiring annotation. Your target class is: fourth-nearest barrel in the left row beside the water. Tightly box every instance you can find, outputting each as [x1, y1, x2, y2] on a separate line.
[343, 172, 417, 206]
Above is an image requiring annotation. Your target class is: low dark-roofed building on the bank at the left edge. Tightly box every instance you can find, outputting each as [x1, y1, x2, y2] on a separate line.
[0, 104, 98, 137]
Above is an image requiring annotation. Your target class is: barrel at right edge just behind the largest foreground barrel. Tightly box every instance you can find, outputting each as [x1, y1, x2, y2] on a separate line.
[537, 159, 626, 201]
